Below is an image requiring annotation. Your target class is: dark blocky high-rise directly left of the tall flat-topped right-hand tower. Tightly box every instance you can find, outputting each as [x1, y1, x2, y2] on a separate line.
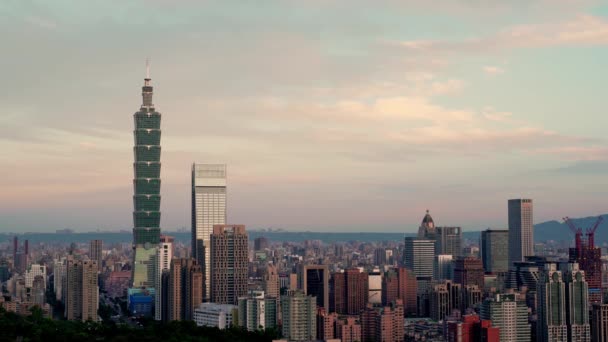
[479, 229, 509, 273]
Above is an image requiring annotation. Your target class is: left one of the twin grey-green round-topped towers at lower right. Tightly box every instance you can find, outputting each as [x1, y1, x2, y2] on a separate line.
[536, 264, 568, 342]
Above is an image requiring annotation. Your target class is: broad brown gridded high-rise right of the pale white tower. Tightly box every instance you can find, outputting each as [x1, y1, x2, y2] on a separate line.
[210, 225, 249, 305]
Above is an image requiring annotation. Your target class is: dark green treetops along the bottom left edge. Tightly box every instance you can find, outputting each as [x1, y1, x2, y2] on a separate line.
[0, 308, 277, 342]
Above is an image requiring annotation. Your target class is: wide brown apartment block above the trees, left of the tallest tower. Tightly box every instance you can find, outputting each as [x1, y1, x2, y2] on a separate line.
[64, 259, 99, 321]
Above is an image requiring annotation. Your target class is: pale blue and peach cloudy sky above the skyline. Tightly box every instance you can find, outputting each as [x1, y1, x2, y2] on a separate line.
[0, 0, 608, 232]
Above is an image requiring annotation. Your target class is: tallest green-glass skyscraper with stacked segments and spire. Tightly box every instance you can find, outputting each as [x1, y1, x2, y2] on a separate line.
[133, 63, 161, 288]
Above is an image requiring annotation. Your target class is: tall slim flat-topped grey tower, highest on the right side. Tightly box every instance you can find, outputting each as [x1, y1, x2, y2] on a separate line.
[509, 199, 534, 267]
